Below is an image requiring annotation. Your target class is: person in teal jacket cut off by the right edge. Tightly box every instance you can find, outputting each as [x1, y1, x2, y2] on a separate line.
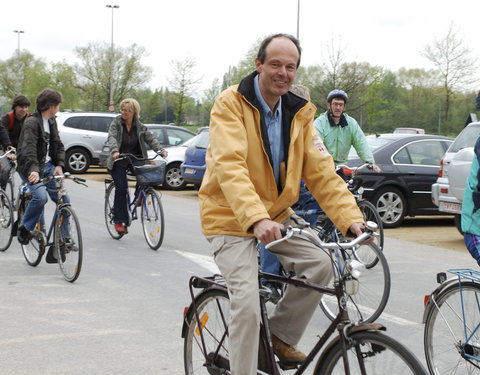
[462, 137, 480, 265]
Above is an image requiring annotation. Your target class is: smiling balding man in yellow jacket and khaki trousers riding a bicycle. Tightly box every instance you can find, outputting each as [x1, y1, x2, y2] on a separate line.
[199, 34, 363, 375]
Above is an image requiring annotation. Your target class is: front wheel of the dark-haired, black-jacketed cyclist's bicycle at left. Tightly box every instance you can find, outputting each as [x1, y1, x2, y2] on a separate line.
[54, 205, 83, 283]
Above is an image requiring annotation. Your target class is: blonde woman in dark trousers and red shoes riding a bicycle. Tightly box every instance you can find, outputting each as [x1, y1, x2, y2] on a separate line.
[107, 98, 168, 234]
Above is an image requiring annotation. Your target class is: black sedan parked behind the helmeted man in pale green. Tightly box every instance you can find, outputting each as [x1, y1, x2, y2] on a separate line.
[348, 134, 453, 228]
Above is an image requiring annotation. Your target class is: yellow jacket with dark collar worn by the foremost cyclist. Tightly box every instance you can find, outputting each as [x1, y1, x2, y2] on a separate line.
[199, 72, 364, 236]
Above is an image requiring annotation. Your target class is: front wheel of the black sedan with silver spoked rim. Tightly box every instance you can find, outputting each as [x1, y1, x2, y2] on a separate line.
[372, 187, 407, 228]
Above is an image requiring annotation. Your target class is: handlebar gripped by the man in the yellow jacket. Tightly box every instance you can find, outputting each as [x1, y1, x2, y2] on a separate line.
[265, 221, 378, 249]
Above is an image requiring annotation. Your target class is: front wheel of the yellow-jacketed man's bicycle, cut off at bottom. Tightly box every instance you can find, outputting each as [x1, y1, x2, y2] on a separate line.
[313, 331, 427, 375]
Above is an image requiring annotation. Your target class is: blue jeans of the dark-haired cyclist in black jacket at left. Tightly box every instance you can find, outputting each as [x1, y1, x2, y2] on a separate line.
[20, 162, 70, 230]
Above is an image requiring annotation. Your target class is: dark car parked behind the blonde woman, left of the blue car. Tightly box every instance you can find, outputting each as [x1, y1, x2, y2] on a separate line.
[100, 124, 196, 190]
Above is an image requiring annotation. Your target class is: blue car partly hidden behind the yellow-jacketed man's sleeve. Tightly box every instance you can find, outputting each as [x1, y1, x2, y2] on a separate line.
[180, 130, 210, 190]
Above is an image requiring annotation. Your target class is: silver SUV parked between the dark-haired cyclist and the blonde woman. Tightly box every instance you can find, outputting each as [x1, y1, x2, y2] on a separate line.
[57, 112, 118, 173]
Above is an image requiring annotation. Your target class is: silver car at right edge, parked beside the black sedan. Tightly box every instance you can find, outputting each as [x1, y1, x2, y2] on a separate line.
[432, 122, 480, 232]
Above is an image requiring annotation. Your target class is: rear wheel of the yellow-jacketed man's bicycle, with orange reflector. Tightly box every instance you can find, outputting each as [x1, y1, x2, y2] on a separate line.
[183, 288, 268, 375]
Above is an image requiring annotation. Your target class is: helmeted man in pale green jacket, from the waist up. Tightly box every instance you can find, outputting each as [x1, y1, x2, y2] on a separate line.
[313, 90, 380, 172]
